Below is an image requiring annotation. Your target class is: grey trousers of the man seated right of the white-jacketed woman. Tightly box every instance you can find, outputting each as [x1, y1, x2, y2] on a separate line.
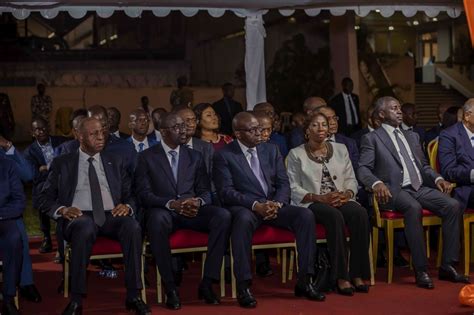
[393, 186, 463, 271]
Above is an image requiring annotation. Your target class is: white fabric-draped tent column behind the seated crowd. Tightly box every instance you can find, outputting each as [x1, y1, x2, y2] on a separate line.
[245, 15, 267, 110]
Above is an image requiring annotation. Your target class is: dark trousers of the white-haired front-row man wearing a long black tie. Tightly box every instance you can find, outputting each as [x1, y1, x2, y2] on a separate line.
[60, 211, 142, 294]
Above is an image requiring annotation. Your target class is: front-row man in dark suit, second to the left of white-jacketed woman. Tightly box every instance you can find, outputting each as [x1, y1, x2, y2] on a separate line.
[135, 113, 231, 309]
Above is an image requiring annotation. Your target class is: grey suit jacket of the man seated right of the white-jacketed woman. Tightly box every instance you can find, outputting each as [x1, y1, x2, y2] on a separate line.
[357, 127, 440, 205]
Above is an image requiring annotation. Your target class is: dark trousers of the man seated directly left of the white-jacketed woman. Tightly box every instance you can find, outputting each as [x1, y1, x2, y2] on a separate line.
[229, 206, 316, 282]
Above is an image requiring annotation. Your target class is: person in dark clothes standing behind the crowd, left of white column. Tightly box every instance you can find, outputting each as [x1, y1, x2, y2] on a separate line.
[212, 83, 243, 136]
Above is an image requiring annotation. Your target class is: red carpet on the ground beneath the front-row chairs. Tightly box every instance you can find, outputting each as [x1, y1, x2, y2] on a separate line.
[15, 241, 474, 315]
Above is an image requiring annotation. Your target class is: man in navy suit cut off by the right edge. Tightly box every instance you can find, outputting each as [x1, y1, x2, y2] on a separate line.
[438, 98, 474, 210]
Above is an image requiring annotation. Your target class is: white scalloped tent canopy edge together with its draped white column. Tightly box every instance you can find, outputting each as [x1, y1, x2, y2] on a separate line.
[0, 0, 463, 109]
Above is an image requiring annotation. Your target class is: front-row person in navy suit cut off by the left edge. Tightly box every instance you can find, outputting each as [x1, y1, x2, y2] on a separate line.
[0, 155, 26, 315]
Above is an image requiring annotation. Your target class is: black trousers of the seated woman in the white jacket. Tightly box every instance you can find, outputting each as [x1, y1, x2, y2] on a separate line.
[309, 201, 370, 285]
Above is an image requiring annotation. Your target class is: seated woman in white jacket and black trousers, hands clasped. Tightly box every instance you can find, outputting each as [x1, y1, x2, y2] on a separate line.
[287, 113, 370, 295]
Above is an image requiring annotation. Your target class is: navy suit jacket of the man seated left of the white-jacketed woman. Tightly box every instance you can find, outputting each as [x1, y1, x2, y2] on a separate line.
[212, 141, 290, 209]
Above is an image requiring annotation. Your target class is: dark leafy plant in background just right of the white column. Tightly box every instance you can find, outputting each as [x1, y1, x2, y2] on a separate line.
[266, 34, 334, 112]
